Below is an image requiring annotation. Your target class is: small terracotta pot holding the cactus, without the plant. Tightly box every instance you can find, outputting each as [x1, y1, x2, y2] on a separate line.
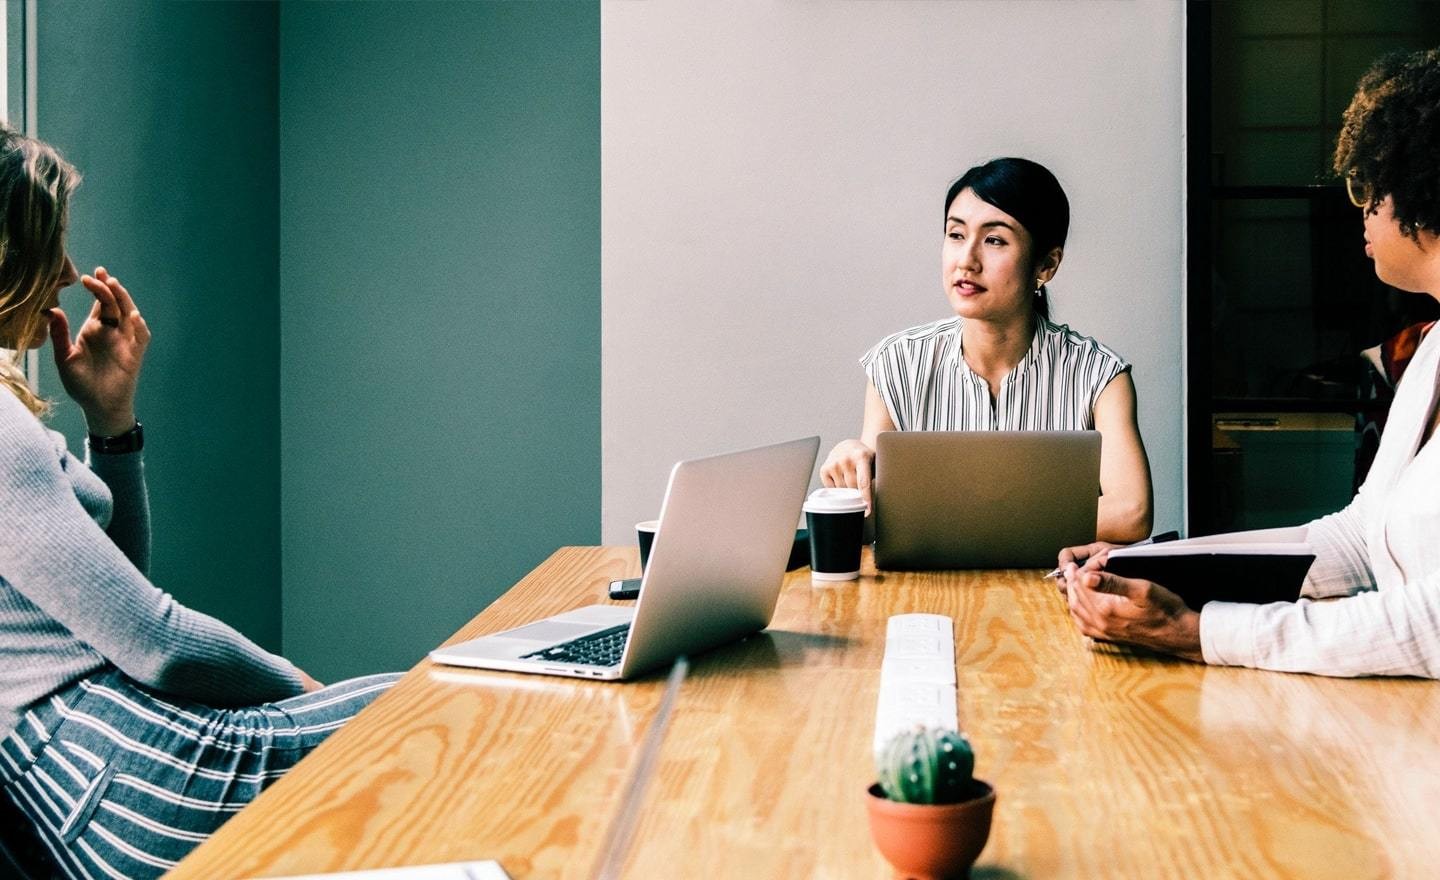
[865, 779, 995, 880]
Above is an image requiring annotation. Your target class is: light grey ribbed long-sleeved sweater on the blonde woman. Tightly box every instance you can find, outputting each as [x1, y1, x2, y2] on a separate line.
[0, 389, 301, 736]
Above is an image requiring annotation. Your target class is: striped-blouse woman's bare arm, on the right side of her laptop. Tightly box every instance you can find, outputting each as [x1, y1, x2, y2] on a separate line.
[1094, 373, 1153, 544]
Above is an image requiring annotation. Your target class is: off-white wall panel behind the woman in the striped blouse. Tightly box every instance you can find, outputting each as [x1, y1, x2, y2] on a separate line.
[600, 0, 1184, 543]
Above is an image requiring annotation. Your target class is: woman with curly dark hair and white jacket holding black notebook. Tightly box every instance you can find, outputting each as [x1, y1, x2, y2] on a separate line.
[1061, 49, 1440, 678]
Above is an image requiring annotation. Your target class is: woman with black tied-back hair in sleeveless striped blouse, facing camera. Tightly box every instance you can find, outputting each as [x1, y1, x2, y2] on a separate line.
[821, 158, 1151, 543]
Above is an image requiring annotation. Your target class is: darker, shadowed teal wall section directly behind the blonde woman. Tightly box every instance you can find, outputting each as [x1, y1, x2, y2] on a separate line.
[37, 0, 281, 650]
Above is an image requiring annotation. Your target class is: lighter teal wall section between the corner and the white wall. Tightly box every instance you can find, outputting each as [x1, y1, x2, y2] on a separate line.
[279, 3, 600, 680]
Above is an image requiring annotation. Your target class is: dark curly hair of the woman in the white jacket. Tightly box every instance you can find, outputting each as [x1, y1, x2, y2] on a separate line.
[1335, 49, 1440, 238]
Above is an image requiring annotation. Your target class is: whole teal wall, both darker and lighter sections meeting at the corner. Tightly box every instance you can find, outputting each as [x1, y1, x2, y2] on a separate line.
[29, 0, 600, 680]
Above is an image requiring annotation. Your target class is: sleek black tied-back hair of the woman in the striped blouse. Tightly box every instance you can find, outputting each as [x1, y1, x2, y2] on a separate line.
[940, 157, 1070, 320]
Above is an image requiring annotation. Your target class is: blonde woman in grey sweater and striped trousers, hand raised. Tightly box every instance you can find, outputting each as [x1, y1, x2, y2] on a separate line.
[0, 128, 395, 877]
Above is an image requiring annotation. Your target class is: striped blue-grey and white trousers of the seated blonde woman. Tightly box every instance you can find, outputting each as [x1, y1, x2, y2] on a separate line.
[0, 670, 399, 880]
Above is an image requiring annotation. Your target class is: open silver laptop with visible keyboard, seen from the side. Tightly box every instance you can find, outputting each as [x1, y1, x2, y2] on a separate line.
[431, 436, 819, 680]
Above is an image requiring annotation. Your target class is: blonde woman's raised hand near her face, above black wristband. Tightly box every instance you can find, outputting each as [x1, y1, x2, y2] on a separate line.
[50, 266, 150, 436]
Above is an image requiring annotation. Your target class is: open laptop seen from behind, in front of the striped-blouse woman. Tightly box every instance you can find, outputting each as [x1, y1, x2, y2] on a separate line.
[874, 431, 1100, 570]
